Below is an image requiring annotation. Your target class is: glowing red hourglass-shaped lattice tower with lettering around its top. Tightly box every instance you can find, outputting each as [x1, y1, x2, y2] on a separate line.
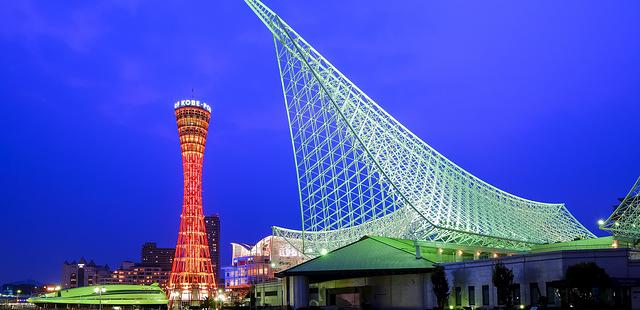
[167, 100, 216, 305]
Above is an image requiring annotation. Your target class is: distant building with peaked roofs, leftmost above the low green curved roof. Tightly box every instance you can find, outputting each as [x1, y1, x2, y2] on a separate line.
[60, 257, 111, 289]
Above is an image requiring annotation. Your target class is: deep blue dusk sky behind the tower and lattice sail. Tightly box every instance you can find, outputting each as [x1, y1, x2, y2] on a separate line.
[0, 0, 640, 284]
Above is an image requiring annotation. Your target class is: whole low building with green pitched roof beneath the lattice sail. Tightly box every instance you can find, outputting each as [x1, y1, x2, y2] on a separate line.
[276, 237, 640, 310]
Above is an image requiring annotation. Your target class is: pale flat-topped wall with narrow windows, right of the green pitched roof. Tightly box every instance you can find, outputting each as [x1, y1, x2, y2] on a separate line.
[442, 248, 640, 309]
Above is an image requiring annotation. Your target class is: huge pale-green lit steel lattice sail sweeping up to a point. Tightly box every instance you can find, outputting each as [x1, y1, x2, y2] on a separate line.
[245, 0, 594, 255]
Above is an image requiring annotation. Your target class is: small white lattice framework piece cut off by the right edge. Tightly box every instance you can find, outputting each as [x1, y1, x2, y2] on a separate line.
[600, 177, 640, 241]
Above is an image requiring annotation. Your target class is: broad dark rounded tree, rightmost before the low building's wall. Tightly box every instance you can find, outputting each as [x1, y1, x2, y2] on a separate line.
[564, 262, 611, 309]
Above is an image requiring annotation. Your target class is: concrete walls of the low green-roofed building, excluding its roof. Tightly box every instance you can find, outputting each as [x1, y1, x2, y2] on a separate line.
[281, 249, 640, 310]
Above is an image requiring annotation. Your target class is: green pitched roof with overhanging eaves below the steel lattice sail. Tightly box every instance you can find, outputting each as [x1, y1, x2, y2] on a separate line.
[276, 236, 435, 277]
